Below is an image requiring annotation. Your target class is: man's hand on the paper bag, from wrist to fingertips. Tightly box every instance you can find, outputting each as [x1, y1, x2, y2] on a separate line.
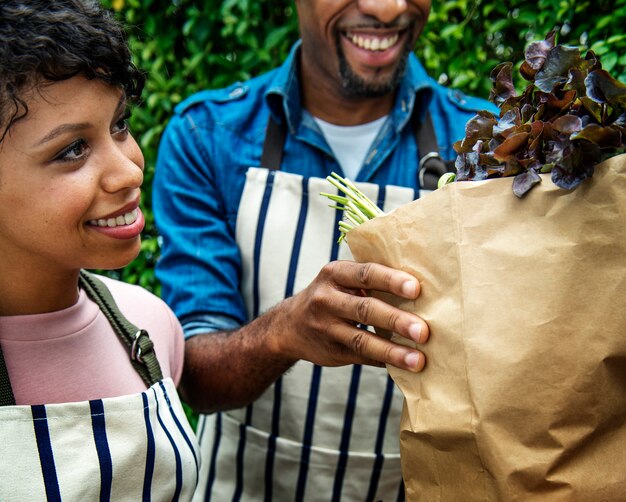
[268, 261, 428, 371]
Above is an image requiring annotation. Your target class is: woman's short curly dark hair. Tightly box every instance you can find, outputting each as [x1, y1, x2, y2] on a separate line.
[0, 0, 145, 142]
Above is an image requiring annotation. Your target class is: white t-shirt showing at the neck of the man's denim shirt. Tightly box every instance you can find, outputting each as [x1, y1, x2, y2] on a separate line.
[314, 115, 387, 180]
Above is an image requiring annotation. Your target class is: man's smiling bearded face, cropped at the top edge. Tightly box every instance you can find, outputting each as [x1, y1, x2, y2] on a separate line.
[296, 0, 431, 98]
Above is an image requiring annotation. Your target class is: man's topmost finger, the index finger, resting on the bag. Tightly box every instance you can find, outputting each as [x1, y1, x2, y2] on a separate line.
[321, 261, 420, 300]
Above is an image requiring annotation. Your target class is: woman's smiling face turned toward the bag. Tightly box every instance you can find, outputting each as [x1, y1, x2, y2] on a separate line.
[0, 76, 144, 273]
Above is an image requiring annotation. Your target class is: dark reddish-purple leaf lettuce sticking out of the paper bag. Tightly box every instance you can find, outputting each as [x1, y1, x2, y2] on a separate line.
[454, 31, 626, 197]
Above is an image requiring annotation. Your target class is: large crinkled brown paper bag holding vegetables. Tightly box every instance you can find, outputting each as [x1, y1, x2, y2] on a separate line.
[348, 155, 626, 502]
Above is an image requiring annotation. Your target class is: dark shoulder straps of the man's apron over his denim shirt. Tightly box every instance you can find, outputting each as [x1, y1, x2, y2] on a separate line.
[261, 111, 455, 190]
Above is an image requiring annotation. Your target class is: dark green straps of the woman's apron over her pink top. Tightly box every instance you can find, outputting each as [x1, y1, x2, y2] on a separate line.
[0, 270, 163, 406]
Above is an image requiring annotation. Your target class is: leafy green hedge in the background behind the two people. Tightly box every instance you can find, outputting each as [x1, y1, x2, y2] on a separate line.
[102, 0, 626, 294]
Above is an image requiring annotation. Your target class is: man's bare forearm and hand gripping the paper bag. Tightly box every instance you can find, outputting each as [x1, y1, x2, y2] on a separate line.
[179, 261, 428, 413]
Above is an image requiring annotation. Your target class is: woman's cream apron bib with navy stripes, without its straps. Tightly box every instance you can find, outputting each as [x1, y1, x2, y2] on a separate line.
[0, 378, 200, 502]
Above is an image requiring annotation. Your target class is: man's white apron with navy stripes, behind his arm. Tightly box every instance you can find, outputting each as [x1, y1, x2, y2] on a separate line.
[194, 168, 416, 502]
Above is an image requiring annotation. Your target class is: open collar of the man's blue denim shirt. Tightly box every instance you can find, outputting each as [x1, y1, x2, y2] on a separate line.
[265, 40, 435, 134]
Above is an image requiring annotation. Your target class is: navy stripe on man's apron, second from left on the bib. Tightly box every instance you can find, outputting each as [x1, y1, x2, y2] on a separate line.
[265, 177, 309, 502]
